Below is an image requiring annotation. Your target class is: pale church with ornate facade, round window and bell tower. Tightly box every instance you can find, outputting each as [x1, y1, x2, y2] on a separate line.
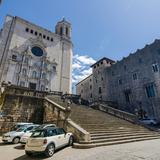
[0, 15, 73, 93]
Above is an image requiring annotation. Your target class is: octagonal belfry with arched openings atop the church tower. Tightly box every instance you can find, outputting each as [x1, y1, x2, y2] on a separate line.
[55, 18, 71, 39]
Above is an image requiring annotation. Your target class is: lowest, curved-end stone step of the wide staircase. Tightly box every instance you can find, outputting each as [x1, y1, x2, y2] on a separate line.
[73, 136, 160, 149]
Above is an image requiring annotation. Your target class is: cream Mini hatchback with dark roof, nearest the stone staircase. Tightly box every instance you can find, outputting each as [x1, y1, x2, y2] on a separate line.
[25, 127, 73, 157]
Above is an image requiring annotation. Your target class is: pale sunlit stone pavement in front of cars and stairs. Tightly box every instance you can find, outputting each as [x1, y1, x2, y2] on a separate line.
[0, 137, 160, 160]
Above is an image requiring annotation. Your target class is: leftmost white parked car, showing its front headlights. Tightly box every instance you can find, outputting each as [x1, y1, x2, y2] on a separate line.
[2, 124, 37, 144]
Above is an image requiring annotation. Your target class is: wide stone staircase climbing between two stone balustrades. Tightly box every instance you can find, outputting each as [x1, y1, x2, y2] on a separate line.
[50, 96, 160, 148]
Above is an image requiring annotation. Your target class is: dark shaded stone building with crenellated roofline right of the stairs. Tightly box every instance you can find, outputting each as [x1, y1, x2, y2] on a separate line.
[77, 40, 160, 120]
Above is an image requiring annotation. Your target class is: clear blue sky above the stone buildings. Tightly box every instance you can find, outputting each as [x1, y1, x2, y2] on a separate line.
[0, 0, 160, 90]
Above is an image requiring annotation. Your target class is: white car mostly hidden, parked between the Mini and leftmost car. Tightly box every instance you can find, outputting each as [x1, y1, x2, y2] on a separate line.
[20, 124, 56, 145]
